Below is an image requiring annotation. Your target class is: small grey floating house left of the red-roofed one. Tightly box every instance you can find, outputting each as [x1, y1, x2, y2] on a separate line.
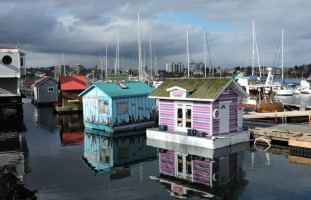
[31, 76, 58, 105]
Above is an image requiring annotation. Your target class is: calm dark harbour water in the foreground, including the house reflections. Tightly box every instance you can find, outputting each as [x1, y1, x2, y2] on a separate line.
[0, 99, 311, 200]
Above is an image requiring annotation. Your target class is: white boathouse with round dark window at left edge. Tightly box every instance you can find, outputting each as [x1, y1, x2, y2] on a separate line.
[0, 47, 26, 114]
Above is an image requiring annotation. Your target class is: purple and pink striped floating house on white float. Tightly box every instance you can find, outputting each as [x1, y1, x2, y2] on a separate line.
[147, 78, 249, 149]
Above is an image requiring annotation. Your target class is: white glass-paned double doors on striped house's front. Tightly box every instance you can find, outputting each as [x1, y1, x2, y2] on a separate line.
[175, 103, 192, 132]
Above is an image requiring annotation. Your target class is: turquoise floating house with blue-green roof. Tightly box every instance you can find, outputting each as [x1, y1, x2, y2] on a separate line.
[79, 81, 156, 133]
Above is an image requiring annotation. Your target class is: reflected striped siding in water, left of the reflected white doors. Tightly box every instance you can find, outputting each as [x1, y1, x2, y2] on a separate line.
[159, 151, 175, 176]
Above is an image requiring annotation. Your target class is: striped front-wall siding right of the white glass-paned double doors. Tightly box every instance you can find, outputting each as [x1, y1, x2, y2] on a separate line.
[193, 102, 211, 135]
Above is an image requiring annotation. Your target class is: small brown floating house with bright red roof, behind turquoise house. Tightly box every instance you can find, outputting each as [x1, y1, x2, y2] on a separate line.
[55, 76, 87, 113]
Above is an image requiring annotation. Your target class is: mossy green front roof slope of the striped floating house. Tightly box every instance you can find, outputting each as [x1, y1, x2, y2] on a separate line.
[149, 78, 232, 99]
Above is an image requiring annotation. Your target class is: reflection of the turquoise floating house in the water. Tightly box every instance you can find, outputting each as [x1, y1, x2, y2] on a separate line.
[81, 129, 157, 179]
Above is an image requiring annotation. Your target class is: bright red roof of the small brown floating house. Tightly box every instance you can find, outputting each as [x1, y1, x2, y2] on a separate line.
[59, 76, 87, 90]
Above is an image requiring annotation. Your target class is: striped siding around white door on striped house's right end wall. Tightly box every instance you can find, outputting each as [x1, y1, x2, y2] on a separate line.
[213, 87, 239, 135]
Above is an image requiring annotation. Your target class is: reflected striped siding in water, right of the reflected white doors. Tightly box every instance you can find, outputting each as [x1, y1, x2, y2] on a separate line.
[192, 159, 211, 186]
